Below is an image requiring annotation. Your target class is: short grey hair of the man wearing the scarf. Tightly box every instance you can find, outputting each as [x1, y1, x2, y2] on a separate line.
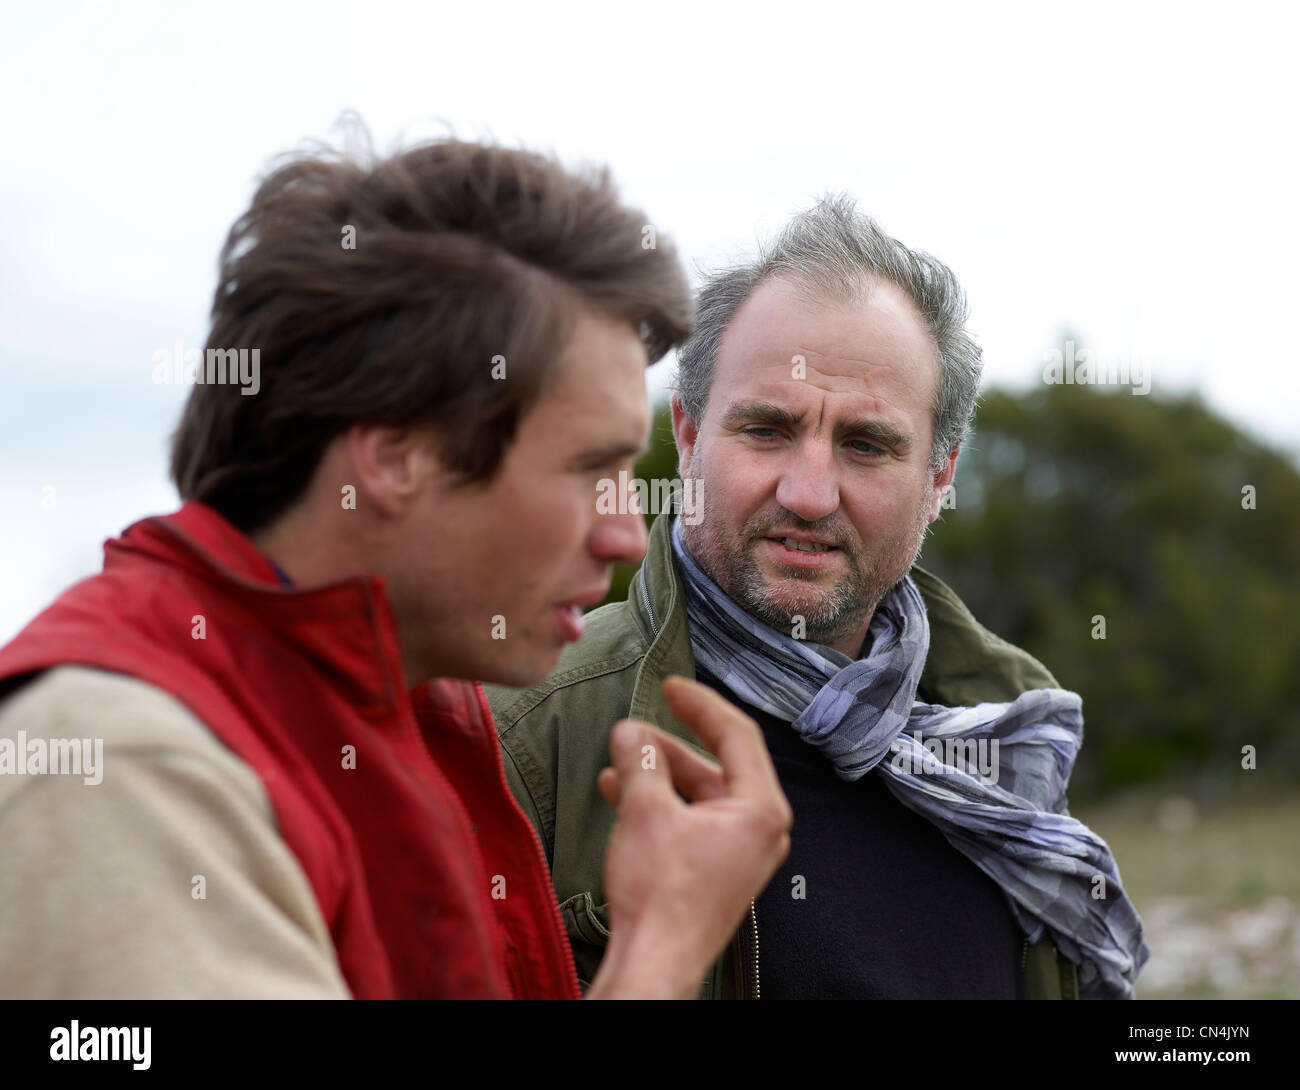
[675, 194, 983, 471]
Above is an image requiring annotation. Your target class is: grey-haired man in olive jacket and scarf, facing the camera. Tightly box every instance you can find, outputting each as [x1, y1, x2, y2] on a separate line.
[490, 198, 1147, 998]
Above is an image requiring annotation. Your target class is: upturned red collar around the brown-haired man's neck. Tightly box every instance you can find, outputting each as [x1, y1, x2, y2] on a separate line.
[115, 501, 406, 719]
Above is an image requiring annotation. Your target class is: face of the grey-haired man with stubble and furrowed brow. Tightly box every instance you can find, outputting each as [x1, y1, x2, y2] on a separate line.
[672, 278, 958, 658]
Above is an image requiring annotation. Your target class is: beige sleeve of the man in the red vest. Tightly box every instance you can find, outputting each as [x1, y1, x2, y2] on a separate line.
[0, 666, 350, 999]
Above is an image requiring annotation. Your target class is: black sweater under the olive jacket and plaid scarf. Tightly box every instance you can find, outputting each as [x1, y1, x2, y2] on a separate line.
[699, 671, 1024, 999]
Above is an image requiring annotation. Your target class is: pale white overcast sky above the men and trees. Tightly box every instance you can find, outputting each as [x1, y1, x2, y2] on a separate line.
[0, 0, 1300, 640]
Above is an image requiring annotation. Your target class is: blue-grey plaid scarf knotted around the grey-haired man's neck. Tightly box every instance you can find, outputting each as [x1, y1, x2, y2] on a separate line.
[672, 522, 1151, 999]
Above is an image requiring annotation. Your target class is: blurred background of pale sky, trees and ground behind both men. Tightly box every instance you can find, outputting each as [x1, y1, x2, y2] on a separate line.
[0, 0, 1300, 998]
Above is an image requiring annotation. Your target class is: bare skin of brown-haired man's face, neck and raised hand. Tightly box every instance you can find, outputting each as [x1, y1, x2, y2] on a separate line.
[255, 307, 792, 999]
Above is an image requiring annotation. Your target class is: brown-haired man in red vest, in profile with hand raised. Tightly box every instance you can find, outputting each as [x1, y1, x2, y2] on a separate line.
[0, 134, 790, 998]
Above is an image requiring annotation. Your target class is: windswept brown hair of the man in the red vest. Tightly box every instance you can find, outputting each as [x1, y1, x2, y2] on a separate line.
[172, 130, 694, 532]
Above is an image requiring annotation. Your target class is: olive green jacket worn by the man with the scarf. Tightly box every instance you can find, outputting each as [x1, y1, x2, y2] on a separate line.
[488, 518, 1078, 999]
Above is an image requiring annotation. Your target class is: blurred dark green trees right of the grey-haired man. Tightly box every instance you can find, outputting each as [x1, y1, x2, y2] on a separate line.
[922, 385, 1300, 796]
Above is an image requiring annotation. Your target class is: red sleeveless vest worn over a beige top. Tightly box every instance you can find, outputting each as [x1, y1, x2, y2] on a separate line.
[0, 503, 580, 999]
